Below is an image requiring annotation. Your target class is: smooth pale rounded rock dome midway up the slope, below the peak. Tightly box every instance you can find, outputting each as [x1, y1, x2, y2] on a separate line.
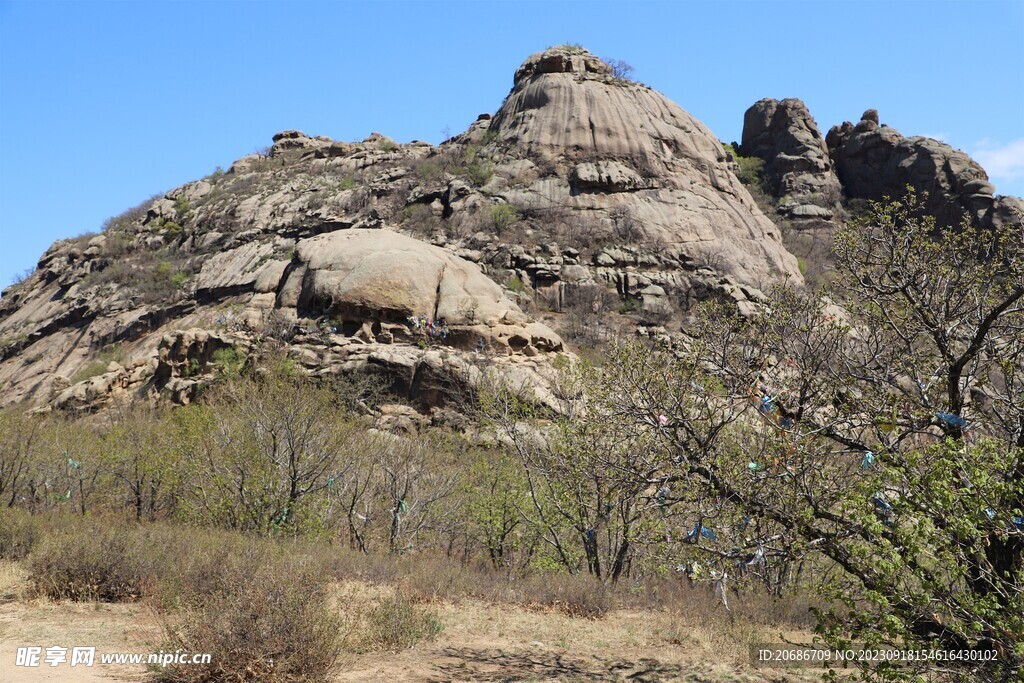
[219, 228, 562, 356]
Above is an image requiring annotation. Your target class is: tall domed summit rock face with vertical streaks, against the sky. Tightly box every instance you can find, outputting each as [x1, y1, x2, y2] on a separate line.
[487, 48, 800, 285]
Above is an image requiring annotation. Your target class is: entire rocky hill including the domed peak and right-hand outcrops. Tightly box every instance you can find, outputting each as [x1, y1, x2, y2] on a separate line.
[0, 46, 1019, 411]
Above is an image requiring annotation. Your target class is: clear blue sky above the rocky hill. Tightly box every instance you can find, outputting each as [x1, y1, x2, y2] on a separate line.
[0, 0, 1024, 287]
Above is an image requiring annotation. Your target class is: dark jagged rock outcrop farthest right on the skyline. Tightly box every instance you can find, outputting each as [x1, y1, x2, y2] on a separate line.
[826, 110, 1020, 231]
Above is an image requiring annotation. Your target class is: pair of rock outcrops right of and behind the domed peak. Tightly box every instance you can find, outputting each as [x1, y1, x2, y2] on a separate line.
[737, 98, 1024, 286]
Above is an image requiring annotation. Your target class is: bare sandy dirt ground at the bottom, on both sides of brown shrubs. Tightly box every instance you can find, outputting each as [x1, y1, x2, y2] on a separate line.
[0, 563, 817, 683]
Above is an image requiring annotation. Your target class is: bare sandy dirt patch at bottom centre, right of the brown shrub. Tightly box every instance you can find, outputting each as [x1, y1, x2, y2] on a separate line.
[336, 600, 815, 683]
